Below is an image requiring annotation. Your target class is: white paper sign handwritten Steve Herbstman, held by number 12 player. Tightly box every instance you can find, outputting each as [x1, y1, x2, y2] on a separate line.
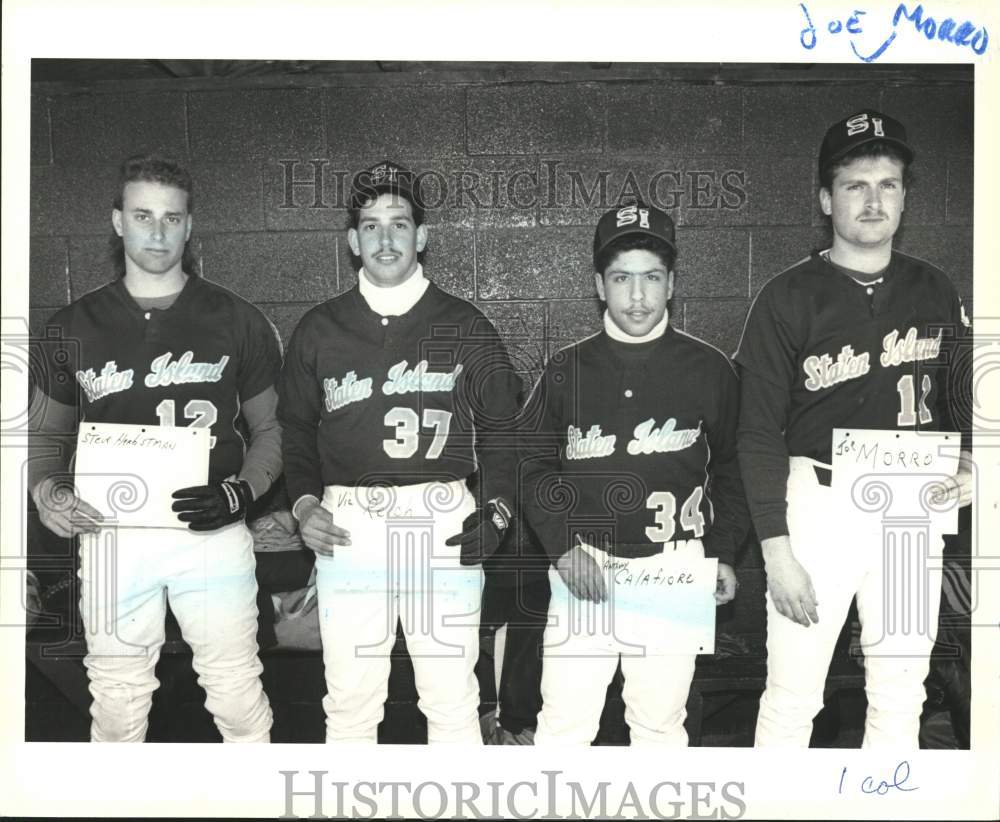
[75, 422, 210, 528]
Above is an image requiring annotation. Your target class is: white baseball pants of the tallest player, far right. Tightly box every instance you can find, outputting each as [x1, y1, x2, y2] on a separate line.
[755, 457, 943, 750]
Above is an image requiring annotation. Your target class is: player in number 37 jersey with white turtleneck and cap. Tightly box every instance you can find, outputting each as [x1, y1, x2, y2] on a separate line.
[279, 160, 520, 744]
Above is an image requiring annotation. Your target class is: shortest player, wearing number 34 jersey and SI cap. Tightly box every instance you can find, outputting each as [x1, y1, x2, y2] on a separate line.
[520, 203, 749, 746]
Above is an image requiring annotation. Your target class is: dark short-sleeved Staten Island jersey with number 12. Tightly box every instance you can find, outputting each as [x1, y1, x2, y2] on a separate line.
[36, 277, 281, 484]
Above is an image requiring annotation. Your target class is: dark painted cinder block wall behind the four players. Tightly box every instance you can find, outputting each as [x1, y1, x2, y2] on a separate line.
[30, 66, 973, 390]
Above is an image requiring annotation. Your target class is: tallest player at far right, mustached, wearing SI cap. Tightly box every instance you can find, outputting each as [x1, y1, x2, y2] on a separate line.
[736, 110, 971, 748]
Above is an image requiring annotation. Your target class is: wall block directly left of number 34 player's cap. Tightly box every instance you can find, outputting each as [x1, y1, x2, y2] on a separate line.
[476, 228, 594, 300]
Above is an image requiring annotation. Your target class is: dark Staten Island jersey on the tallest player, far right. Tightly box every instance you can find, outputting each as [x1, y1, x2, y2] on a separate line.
[735, 251, 970, 539]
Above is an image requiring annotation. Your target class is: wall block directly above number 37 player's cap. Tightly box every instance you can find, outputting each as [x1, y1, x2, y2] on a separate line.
[324, 86, 465, 159]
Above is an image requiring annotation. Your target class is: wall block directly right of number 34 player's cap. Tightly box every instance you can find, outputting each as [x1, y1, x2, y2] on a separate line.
[674, 228, 750, 303]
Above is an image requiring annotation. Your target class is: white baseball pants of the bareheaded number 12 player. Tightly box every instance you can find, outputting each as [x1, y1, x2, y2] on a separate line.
[79, 522, 272, 742]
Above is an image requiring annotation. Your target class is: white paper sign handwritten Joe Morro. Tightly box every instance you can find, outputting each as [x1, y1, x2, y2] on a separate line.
[832, 428, 961, 533]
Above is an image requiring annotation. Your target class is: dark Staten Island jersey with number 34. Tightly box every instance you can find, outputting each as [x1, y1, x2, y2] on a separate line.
[519, 327, 749, 564]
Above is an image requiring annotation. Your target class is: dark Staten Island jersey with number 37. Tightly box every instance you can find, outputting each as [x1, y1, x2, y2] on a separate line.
[278, 283, 521, 503]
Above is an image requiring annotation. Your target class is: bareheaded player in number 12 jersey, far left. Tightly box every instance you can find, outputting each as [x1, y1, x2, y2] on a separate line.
[29, 156, 281, 742]
